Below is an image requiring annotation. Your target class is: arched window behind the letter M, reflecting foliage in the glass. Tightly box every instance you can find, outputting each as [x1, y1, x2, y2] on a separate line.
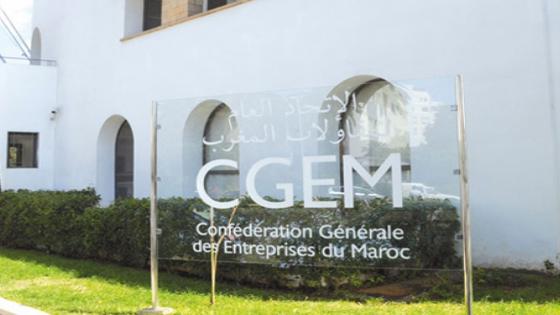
[339, 79, 411, 196]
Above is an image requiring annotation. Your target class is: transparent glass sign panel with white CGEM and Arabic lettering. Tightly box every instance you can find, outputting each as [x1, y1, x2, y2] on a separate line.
[157, 76, 462, 296]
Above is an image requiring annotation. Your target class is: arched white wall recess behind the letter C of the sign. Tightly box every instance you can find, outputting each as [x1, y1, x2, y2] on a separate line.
[183, 100, 239, 197]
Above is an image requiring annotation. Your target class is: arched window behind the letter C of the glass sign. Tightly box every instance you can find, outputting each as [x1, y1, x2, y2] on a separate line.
[202, 103, 239, 199]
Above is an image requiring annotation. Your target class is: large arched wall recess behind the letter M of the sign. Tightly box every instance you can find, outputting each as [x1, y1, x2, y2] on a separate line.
[319, 75, 411, 194]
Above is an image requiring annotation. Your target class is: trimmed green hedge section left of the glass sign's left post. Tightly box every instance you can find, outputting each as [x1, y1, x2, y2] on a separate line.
[0, 189, 149, 267]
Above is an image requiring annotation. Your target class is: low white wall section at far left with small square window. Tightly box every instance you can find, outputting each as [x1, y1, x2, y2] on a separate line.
[0, 63, 57, 189]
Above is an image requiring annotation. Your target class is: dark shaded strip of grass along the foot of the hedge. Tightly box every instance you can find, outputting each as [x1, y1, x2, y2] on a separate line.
[0, 248, 560, 303]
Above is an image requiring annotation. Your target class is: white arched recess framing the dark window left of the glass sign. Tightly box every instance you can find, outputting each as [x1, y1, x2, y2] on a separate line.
[95, 115, 134, 205]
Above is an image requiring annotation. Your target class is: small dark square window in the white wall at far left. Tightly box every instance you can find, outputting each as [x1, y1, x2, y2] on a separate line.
[8, 132, 39, 168]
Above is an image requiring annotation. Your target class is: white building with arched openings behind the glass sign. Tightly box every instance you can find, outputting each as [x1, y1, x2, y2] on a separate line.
[0, 0, 560, 269]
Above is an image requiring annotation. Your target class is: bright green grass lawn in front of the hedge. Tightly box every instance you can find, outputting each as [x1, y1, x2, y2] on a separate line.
[0, 248, 560, 315]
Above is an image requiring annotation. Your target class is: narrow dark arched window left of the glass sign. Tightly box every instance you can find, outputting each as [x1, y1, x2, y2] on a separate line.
[115, 121, 134, 199]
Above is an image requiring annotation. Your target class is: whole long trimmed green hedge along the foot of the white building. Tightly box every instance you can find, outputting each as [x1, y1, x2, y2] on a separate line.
[0, 189, 460, 288]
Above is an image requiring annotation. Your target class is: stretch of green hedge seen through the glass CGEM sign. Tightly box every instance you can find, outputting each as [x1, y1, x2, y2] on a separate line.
[159, 198, 460, 268]
